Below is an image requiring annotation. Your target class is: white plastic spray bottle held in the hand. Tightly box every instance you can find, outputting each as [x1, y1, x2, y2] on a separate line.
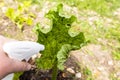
[2, 41, 45, 80]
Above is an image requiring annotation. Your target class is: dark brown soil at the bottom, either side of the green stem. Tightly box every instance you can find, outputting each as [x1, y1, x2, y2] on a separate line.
[19, 69, 73, 80]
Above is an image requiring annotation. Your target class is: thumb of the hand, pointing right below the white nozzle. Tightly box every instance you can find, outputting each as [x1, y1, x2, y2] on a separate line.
[11, 59, 32, 72]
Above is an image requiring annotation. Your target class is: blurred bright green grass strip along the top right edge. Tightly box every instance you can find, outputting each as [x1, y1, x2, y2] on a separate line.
[36, 0, 120, 15]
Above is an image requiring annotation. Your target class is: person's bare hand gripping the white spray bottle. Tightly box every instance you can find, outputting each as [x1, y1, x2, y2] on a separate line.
[0, 36, 32, 79]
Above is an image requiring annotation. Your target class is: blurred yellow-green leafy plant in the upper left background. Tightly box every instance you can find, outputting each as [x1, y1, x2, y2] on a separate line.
[6, 1, 35, 29]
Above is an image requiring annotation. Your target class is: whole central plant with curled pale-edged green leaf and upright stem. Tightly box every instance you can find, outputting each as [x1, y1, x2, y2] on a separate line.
[35, 4, 85, 80]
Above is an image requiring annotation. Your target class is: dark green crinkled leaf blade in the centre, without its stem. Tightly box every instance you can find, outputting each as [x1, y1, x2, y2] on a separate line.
[36, 3, 85, 70]
